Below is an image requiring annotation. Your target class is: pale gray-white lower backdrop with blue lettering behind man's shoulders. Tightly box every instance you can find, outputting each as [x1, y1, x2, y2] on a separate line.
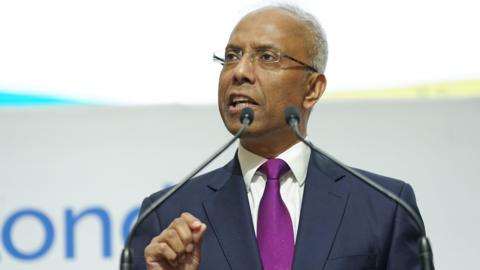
[0, 99, 480, 270]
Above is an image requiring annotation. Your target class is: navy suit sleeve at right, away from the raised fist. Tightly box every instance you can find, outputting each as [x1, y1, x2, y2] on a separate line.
[387, 184, 421, 270]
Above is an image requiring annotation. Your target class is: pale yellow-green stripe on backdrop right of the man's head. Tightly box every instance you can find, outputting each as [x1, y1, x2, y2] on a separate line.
[323, 80, 480, 100]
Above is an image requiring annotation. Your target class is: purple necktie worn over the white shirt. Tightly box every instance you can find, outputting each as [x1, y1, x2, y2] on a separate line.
[257, 159, 294, 270]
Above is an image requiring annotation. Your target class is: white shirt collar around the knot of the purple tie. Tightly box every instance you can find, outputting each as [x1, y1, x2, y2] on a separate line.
[238, 142, 311, 190]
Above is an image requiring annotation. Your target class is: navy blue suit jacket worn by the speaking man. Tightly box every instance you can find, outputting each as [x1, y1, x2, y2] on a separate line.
[133, 153, 420, 270]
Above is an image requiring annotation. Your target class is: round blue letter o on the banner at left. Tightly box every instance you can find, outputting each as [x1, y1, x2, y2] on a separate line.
[2, 209, 54, 260]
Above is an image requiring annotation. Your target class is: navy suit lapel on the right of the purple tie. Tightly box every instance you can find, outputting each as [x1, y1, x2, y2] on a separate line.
[293, 153, 349, 270]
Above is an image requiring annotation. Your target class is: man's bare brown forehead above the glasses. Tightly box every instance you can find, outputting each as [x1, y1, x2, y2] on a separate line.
[228, 9, 310, 54]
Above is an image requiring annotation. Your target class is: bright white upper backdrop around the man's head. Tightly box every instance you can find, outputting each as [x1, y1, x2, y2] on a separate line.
[0, 0, 480, 104]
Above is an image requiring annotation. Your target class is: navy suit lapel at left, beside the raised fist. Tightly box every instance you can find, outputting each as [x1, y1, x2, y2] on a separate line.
[203, 158, 262, 270]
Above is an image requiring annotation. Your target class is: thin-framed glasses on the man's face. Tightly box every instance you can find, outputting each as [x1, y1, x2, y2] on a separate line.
[213, 49, 318, 72]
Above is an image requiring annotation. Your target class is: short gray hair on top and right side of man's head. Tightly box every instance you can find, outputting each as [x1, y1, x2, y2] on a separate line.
[258, 3, 328, 73]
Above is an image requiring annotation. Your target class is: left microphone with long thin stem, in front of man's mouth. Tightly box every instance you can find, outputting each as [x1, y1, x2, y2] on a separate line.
[120, 107, 253, 270]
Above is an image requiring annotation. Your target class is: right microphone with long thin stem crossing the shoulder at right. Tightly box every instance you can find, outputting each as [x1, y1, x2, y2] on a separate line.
[285, 106, 435, 270]
